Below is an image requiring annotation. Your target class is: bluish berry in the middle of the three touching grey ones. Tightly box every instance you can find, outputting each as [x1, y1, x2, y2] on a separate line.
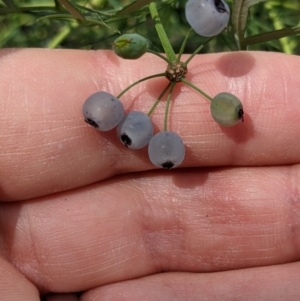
[117, 111, 153, 149]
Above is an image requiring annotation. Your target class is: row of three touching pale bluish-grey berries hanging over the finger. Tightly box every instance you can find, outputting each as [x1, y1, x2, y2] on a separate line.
[82, 91, 185, 169]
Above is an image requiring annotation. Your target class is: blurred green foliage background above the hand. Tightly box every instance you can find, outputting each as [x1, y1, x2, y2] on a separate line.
[0, 0, 300, 54]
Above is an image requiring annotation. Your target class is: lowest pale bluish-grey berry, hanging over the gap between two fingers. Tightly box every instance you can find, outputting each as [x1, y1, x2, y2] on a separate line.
[148, 131, 185, 169]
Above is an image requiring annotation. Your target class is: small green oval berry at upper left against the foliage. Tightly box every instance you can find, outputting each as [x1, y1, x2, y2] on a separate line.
[113, 33, 148, 60]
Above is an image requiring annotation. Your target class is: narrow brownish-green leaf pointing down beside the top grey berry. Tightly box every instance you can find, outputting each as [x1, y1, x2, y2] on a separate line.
[232, 0, 267, 48]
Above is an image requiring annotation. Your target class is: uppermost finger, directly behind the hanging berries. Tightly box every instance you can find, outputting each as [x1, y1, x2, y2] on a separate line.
[0, 49, 300, 200]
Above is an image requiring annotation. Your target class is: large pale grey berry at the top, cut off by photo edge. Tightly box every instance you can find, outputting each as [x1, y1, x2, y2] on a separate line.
[185, 0, 230, 37]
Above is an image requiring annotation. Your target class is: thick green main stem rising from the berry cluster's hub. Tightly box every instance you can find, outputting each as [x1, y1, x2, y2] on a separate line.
[149, 2, 176, 63]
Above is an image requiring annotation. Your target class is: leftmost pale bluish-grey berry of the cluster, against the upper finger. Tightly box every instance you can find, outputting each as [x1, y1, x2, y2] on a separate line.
[82, 91, 124, 132]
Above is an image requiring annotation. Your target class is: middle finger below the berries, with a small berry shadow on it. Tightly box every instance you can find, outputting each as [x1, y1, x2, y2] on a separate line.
[0, 166, 300, 292]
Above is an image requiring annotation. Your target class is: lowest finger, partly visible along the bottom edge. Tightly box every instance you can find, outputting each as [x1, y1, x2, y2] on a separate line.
[82, 262, 300, 301]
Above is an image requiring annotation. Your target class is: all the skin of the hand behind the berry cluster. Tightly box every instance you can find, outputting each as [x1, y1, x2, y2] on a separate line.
[0, 49, 300, 301]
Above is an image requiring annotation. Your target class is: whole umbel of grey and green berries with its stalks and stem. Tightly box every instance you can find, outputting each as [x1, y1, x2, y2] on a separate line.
[82, 0, 244, 169]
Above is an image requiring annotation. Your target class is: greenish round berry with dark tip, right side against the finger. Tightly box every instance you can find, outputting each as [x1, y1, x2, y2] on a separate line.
[210, 92, 244, 126]
